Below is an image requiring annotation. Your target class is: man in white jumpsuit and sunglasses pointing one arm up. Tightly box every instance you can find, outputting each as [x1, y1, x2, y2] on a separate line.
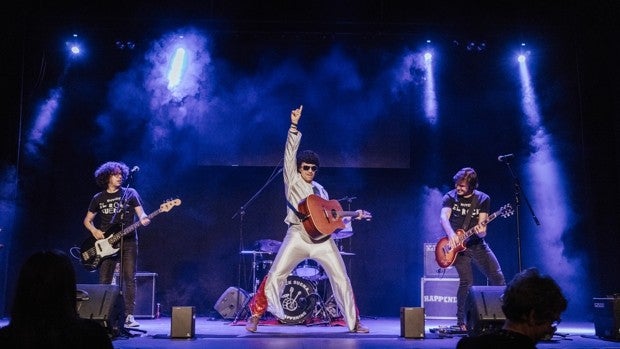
[246, 106, 370, 333]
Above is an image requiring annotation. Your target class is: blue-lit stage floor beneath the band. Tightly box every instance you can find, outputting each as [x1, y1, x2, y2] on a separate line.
[0, 317, 620, 349]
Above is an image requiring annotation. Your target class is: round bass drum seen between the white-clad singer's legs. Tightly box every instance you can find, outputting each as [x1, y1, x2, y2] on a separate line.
[280, 275, 318, 324]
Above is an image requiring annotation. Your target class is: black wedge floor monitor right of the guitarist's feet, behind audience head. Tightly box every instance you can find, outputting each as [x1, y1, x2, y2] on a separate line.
[465, 286, 506, 336]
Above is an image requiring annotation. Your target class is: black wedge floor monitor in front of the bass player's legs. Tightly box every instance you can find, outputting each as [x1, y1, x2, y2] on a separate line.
[76, 284, 125, 337]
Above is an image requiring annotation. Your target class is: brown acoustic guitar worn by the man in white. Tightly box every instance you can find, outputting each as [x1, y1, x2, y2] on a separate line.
[297, 194, 372, 240]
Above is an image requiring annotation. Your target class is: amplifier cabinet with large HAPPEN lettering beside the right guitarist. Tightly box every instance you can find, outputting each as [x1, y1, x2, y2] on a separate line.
[420, 278, 459, 319]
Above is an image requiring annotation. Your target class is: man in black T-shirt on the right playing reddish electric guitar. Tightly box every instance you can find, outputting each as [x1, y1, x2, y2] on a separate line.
[435, 167, 506, 331]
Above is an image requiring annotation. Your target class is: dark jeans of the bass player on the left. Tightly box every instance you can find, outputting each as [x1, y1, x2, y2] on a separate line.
[99, 237, 138, 315]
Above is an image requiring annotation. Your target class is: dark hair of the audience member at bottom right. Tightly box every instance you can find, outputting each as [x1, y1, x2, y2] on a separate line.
[502, 268, 568, 323]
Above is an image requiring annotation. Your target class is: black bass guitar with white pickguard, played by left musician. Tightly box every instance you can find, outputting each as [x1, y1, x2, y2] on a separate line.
[80, 199, 181, 271]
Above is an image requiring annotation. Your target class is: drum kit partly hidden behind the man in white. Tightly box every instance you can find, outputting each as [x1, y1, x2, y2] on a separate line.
[241, 223, 355, 325]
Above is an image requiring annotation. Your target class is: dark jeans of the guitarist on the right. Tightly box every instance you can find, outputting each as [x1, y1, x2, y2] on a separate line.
[454, 242, 506, 325]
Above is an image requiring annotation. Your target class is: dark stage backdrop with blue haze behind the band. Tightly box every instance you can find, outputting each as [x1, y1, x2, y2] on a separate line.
[0, 1, 620, 317]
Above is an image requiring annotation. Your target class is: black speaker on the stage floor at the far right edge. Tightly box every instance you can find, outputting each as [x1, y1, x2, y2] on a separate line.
[593, 294, 620, 340]
